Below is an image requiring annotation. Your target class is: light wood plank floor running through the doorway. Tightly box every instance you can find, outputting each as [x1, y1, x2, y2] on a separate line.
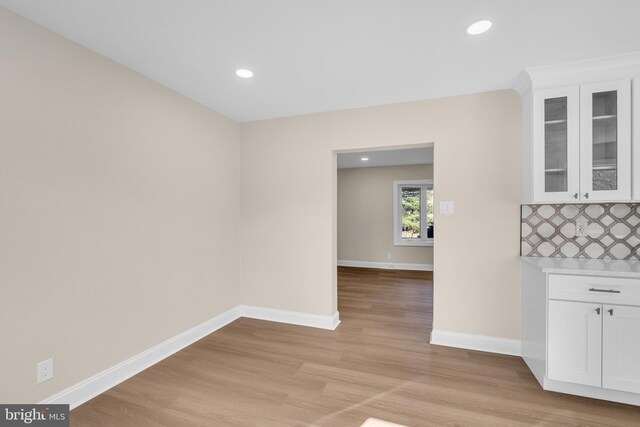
[71, 268, 640, 427]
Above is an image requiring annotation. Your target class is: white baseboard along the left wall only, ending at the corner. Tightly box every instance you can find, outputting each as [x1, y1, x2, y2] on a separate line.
[40, 307, 240, 409]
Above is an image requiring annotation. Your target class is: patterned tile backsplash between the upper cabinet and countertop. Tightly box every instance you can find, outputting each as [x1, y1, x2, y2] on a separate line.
[520, 203, 640, 260]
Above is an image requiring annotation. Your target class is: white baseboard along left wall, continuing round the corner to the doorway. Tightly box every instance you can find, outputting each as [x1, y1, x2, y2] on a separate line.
[40, 305, 340, 409]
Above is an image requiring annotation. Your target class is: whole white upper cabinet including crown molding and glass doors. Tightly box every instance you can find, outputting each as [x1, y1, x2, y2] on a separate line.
[517, 53, 640, 204]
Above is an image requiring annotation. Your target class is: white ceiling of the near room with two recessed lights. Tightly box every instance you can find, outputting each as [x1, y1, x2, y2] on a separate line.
[0, 0, 640, 122]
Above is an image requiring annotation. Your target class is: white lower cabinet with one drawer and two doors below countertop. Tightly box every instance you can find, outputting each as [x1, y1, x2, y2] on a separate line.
[521, 262, 640, 406]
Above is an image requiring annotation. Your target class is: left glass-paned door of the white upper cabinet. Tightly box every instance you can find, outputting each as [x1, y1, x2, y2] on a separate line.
[533, 86, 580, 203]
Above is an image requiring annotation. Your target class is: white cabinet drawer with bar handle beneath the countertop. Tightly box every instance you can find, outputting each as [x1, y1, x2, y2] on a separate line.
[549, 274, 640, 305]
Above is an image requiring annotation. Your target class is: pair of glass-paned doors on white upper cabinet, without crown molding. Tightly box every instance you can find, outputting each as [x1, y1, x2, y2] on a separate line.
[532, 79, 631, 203]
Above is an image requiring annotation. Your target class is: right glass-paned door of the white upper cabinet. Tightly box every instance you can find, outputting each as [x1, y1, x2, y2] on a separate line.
[580, 80, 631, 202]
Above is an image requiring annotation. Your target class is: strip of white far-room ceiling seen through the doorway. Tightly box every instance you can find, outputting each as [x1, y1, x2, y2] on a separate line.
[338, 147, 433, 169]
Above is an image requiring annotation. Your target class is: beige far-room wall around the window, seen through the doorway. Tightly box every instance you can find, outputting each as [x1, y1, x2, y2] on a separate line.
[337, 165, 433, 265]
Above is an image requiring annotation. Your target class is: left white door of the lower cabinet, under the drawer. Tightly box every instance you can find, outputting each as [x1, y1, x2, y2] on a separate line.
[547, 300, 602, 387]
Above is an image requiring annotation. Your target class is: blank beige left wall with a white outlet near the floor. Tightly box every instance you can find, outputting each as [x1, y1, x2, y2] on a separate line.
[0, 8, 241, 403]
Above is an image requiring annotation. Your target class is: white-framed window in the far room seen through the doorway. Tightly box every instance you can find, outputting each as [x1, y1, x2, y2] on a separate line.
[393, 179, 433, 246]
